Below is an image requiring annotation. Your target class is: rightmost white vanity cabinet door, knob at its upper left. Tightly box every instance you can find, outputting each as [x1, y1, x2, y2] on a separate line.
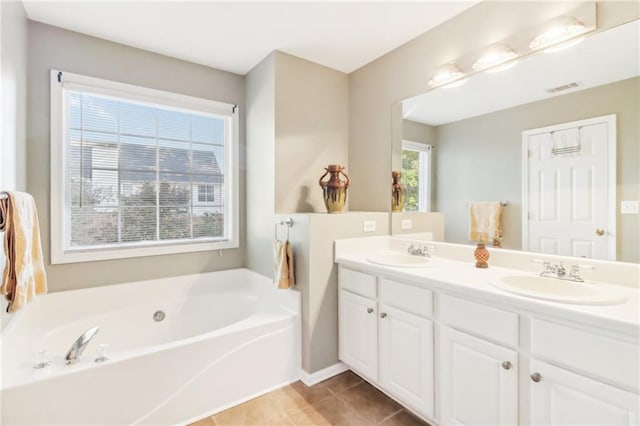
[530, 359, 639, 426]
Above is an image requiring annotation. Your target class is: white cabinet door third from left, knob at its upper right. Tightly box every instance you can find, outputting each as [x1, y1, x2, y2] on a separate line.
[439, 327, 518, 426]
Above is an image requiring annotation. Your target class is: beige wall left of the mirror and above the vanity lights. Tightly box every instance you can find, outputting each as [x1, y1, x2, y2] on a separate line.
[349, 1, 639, 211]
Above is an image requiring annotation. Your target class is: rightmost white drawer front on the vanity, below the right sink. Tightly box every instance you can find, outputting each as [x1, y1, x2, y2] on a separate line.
[531, 319, 640, 390]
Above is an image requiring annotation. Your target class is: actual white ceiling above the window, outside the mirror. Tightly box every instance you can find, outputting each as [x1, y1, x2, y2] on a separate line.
[23, 0, 478, 74]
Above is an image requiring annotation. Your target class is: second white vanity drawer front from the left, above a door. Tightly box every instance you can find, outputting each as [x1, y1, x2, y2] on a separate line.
[380, 278, 433, 317]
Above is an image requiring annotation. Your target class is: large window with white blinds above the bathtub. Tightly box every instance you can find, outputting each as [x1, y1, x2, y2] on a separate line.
[52, 70, 237, 261]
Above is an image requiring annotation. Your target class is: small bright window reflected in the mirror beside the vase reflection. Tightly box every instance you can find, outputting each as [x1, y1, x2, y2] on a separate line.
[402, 140, 432, 212]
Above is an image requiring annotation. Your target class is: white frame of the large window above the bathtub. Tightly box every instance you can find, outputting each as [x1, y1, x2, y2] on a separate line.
[51, 70, 239, 264]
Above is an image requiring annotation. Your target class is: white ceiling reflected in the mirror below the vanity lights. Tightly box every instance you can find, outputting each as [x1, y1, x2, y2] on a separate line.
[402, 21, 640, 126]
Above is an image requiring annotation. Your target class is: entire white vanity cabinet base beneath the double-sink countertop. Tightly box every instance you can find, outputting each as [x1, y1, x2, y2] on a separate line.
[339, 265, 640, 426]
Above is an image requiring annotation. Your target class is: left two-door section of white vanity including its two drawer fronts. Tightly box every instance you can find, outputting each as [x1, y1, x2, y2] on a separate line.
[339, 267, 434, 418]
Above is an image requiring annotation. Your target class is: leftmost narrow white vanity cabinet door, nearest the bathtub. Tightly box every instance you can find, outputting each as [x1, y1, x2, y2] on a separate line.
[339, 290, 378, 380]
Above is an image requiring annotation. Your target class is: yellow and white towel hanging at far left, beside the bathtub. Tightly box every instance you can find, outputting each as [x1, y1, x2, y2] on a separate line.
[0, 192, 47, 312]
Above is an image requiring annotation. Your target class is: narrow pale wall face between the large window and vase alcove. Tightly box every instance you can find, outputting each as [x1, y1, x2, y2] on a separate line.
[245, 53, 276, 277]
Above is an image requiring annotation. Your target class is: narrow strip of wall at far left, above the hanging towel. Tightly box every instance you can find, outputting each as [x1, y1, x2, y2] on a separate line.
[0, 1, 27, 191]
